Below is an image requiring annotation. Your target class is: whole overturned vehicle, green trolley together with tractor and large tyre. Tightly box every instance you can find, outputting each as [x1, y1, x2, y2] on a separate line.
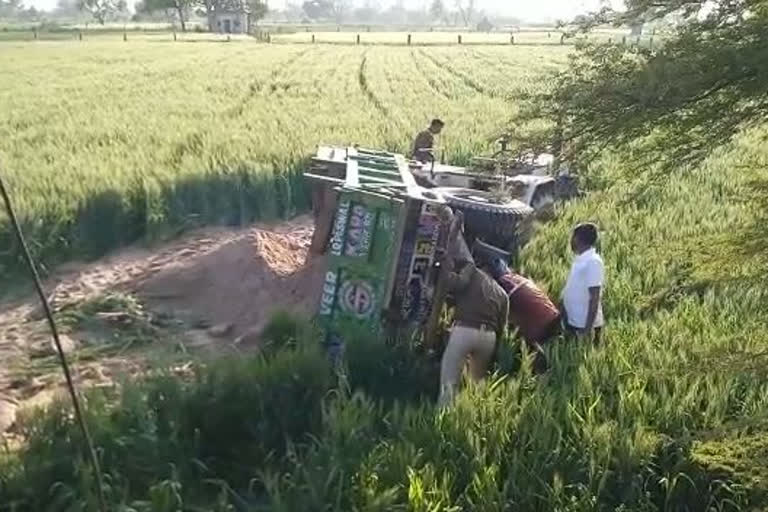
[304, 146, 572, 347]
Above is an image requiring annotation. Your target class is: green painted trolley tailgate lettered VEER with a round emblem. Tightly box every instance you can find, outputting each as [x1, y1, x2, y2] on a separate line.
[318, 189, 405, 338]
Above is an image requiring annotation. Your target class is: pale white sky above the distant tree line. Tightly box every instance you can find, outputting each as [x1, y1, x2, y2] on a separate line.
[25, 0, 620, 21]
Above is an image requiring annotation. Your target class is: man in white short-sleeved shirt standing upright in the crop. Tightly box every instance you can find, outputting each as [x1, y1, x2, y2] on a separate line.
[563, 224, 605, 343]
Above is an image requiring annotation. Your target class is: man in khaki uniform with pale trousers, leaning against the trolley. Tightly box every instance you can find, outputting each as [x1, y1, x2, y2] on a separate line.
[438, 259, 509, 406]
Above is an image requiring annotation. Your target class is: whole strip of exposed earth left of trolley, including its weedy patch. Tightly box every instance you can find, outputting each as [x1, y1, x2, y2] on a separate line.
[0, 216, 324, 436]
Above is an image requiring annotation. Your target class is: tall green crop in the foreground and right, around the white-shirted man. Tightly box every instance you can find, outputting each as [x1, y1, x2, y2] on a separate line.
[0, 126, 768, 511]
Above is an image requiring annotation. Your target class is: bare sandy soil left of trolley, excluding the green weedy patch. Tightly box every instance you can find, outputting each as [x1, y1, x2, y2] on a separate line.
[0, 216, 324, 418]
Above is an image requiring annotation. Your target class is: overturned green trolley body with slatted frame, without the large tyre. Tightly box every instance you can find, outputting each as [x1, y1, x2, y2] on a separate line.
[305, 147, 532, 347]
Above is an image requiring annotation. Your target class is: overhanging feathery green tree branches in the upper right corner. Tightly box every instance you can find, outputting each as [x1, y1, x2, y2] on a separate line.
[527, 0, 768, 173]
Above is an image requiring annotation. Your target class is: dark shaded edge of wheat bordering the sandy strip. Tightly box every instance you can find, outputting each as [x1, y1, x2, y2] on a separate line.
[0, 164, 309, 284]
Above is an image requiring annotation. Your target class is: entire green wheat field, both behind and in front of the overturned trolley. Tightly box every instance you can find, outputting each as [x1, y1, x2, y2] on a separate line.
[0, 38, 768, 512]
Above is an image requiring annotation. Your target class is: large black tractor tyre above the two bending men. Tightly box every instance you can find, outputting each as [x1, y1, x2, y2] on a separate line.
[433, 188, 533, 259]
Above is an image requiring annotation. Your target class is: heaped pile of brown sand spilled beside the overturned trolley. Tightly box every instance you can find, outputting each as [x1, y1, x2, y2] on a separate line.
[135, 219, 323, 336]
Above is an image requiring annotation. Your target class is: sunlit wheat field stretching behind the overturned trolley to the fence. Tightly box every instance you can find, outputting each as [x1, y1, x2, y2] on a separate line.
[0, 42, 566, 272]
